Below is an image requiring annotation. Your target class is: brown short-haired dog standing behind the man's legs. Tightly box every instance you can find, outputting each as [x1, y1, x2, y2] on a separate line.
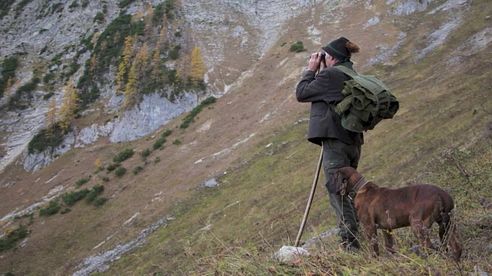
[335, 167, 462, 261]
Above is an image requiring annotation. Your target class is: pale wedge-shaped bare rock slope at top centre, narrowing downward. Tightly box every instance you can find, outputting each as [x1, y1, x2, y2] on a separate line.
[183, 0, 318, 94]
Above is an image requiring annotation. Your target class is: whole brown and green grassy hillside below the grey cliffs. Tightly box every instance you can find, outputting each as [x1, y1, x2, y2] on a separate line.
[0, 0, 492, 275]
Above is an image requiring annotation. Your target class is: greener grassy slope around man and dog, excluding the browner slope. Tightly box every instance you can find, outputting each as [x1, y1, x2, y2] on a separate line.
[101, 1, 492, 275]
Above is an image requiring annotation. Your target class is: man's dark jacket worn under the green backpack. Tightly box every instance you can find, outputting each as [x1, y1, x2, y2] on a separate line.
[296, 62, 363, 145]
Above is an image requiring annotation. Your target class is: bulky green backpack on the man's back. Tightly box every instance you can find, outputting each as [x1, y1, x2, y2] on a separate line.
[335, 65, 399, 132]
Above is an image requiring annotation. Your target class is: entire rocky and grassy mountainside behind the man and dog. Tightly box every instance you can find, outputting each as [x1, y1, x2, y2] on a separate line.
[0, 0, 492, 275]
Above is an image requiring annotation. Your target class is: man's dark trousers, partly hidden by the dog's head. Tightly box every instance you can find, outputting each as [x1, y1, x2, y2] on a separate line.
[323, 139, 361, 243]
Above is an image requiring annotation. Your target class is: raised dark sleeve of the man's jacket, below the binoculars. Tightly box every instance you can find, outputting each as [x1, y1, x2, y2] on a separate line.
[296, 69, 341, 102]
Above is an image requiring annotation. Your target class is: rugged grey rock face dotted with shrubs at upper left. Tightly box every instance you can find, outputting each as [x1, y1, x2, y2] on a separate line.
[0, 0, 198, 170]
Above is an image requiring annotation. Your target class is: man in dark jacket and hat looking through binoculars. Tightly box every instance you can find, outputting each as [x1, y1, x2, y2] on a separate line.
[296, 37, 363, 250]
